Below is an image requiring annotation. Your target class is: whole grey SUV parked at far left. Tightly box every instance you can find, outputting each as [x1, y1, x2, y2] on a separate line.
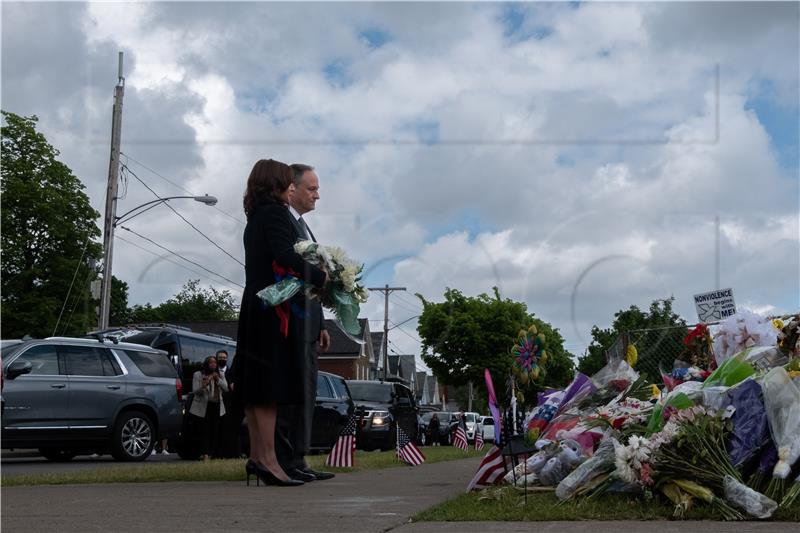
[2, 337, 182, 461]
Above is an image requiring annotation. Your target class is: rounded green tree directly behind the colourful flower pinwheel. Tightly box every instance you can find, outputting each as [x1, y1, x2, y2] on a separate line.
[417, 287, 573, 408]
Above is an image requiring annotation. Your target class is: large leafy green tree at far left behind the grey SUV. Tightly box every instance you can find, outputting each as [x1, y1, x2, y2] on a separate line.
[0, 111, 102, 338]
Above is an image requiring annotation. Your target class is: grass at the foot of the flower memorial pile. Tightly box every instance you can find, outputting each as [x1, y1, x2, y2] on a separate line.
[414, 487, 800, 522]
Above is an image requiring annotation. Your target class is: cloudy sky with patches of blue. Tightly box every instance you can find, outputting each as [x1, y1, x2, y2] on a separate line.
[2, 2, 800, 364]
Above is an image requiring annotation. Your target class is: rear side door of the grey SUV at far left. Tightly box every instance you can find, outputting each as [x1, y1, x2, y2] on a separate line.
[59, 345, 127, 438]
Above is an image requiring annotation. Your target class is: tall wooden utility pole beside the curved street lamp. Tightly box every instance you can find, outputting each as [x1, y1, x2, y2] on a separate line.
[98, 52, 125, 330]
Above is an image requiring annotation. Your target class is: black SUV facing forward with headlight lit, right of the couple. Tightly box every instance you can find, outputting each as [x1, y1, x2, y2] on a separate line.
[347, 380, 419, 450]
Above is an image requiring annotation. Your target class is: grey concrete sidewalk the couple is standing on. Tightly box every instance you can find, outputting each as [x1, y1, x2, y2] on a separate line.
[2, 458, 480, 533]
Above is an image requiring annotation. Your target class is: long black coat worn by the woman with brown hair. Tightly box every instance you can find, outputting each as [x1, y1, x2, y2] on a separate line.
[234, 203, 325, 406]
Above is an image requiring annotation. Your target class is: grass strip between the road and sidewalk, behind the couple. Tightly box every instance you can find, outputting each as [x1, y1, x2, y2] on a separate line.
[2, 446, 486, 487]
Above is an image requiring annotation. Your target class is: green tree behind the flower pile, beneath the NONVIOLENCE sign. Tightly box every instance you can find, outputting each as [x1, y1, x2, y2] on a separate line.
[578, 297, 686, 381]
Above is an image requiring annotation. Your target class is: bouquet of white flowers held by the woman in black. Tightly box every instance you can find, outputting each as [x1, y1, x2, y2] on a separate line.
[257, 240, 369, 336]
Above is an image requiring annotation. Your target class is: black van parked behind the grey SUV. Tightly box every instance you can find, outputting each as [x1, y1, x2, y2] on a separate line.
[87, 324, 236, 392]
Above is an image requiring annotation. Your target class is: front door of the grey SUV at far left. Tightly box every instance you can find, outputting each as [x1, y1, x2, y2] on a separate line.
[2, 344, 69, 447]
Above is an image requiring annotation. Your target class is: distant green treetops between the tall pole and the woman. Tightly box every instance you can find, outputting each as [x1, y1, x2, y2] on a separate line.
[130, 279, 239, 323]
